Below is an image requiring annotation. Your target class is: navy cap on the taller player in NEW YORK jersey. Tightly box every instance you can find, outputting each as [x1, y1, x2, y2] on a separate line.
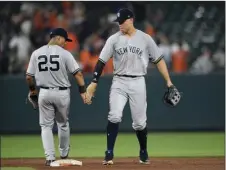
[114, 8, 134, 24]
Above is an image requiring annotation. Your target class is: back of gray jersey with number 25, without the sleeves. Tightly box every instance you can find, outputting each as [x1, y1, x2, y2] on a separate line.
[32, 45, 75, 87]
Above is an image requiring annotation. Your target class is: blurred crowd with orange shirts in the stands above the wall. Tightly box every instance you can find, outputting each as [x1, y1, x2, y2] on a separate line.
[0, 1, 225, 74]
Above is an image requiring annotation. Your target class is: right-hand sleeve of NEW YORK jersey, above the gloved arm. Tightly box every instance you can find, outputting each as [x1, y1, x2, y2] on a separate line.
[147, 35, 163, 64]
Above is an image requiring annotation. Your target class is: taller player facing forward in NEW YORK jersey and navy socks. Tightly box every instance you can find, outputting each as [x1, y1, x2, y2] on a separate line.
[87, 9, 180, 165]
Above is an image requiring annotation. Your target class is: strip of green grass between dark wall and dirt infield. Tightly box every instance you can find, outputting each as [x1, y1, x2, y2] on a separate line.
[1, 132, 224, 158]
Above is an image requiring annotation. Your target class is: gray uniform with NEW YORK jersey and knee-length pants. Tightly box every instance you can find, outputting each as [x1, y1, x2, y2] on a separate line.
[99, 30, 163, 130]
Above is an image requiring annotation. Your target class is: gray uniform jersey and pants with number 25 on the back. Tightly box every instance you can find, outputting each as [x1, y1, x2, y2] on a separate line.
[27, 45, 79, 160]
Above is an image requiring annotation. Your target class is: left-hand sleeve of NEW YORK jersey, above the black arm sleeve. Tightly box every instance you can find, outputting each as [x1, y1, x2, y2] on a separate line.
[99, 37, 113, 64]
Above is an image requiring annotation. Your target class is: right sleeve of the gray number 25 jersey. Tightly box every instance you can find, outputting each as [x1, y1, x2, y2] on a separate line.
[66, 52, 80, 75]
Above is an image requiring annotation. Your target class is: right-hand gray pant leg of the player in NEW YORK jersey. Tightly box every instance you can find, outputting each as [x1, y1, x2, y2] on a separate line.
[128, 77, 147, 130]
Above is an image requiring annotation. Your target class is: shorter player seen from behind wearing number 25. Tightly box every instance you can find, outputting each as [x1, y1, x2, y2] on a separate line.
[26, 28, 90, 166]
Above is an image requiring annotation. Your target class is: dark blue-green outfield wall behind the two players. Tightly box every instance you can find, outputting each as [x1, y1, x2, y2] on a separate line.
[0, 74, 225, 133]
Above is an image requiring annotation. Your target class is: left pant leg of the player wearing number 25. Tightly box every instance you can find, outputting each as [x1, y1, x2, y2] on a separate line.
[38, 90, 55, 160]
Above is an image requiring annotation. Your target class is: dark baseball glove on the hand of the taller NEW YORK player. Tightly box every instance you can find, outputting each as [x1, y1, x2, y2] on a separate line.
[163, 85, 182, 107]
